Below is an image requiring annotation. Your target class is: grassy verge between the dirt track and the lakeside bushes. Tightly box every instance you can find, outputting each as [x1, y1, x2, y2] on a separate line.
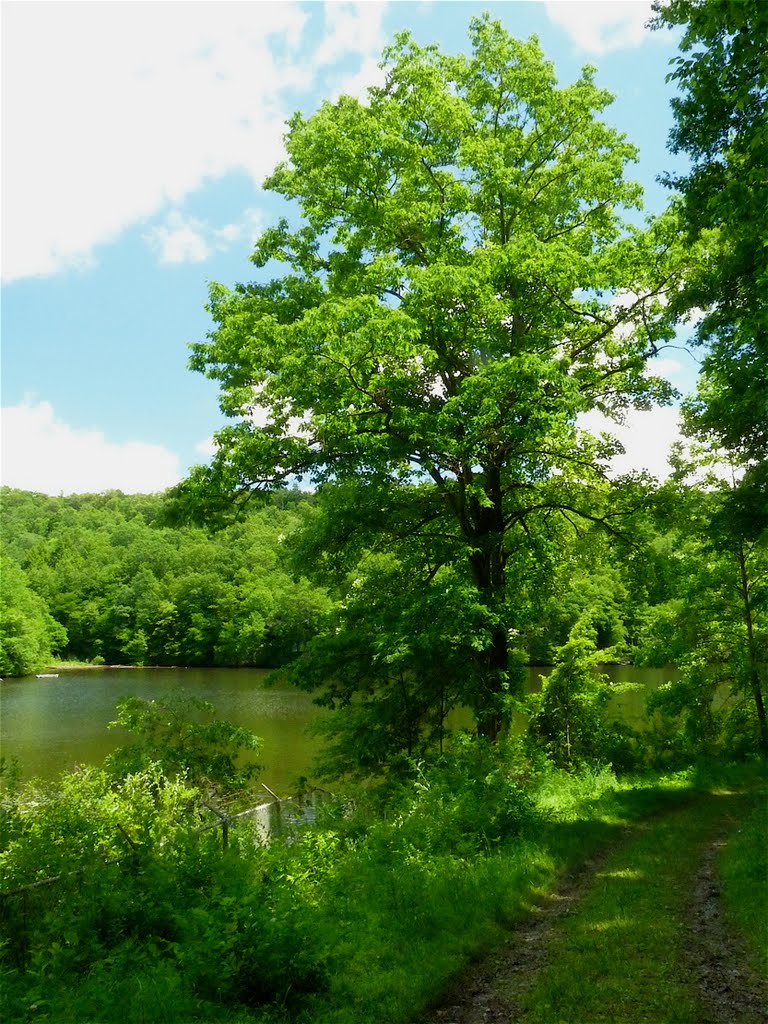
[305, 771, 695, 1024]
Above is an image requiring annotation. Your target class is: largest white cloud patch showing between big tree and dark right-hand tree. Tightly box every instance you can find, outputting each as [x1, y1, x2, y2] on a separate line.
[579, 406, 682, 480]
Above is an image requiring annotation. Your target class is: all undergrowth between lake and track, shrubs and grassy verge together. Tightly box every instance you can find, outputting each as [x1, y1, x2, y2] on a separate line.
[0, 740, 757, 1024]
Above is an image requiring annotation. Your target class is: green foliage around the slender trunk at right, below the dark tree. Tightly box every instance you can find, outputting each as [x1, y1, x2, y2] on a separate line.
[639, 480, 768, 764]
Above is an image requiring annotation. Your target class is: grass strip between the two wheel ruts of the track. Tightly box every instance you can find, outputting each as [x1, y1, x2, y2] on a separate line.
[505, 794, 765, 1024]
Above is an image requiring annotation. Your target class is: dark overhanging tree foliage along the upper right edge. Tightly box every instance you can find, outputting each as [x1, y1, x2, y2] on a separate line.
[654, 0, 768, 537]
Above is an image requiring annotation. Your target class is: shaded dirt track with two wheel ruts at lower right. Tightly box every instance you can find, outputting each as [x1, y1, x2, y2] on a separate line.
[421, 799, 768, 1024]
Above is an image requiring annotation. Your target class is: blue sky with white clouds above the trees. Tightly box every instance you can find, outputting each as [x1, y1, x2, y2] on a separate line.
[0, 0, 695, 495]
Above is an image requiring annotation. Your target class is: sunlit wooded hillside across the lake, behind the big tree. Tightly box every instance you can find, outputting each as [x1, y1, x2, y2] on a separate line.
[0, 479, 672, 676]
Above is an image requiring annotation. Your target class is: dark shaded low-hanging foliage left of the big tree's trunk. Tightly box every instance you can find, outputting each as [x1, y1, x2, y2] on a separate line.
[290, 512, 518, 777]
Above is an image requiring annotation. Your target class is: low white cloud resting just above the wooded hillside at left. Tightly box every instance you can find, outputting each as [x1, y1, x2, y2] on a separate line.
[0, 401, 181, 495]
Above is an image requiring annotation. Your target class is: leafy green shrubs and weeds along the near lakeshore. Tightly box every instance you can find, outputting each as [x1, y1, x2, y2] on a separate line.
[0, 743, 541, 1024]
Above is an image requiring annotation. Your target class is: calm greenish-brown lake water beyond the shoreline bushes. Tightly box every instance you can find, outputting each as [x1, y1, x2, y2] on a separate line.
[0, 666, 676, 796]
